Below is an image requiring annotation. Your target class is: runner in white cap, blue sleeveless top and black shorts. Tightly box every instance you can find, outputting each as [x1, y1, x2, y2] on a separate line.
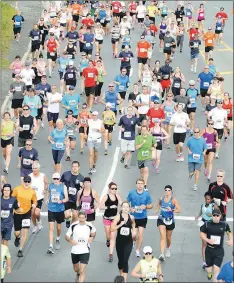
[45, 172, 68, 254]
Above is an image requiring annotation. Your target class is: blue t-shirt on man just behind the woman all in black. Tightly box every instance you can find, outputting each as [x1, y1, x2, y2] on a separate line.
[127, 189, 152, 219]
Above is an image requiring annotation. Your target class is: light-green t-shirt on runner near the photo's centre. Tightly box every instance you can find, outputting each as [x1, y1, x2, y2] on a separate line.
[135, 135, 157, 160]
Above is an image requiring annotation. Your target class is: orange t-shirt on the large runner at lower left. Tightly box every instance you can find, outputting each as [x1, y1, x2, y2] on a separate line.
[12, 185, 37, 214]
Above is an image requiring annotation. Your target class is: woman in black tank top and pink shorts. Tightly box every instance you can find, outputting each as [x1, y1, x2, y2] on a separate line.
[100, 182, 122, 262]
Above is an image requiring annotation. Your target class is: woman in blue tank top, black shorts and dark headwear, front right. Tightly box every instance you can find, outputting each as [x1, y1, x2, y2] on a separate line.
[156, 185, 180, 261]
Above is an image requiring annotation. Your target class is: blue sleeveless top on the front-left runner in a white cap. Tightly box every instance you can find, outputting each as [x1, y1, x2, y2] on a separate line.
[48, 183, 65, 212]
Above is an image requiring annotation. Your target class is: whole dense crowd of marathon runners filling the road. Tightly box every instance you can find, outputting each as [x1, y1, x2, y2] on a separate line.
[1, 0, 233, 282]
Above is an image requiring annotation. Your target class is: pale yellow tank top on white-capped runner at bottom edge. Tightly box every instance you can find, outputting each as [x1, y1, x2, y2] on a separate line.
[140, 257, 159, 282]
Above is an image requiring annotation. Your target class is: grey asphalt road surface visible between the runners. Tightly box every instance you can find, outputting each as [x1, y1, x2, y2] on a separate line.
[2, 1, 233, 282]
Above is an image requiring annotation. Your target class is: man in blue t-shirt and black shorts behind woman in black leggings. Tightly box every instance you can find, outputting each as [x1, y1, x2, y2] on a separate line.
[127, 179, 153, 257]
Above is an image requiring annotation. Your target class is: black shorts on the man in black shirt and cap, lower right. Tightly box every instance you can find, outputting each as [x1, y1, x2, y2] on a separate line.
[205, 246, 224, 267]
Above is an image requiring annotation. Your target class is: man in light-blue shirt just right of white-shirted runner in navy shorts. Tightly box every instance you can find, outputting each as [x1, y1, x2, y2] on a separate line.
[61, 85, 80, 119]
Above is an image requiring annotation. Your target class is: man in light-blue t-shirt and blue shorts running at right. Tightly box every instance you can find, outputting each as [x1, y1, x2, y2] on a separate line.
[187, 128, 207, 191]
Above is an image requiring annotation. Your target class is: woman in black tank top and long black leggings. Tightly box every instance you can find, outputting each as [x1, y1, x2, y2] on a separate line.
[111, 201, 136, 282]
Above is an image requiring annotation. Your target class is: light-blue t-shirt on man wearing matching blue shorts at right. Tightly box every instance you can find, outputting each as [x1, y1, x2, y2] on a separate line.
[187, 137, 207, 163]
